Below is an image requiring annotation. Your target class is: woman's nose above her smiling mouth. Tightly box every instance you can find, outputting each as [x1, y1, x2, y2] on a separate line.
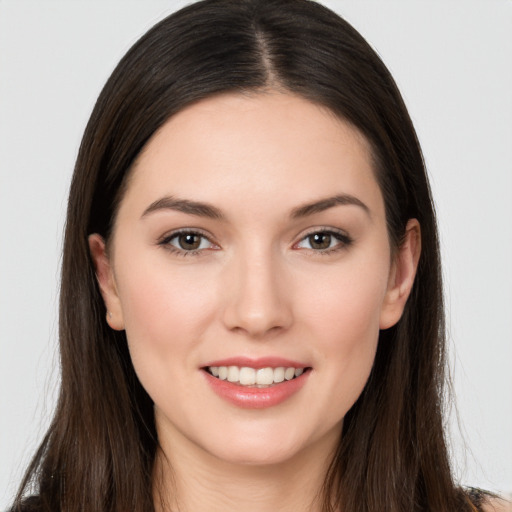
[221, 252, 293, 339]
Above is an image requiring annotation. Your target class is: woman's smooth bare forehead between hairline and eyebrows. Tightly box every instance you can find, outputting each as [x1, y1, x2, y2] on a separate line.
[121, 92, 381, 219]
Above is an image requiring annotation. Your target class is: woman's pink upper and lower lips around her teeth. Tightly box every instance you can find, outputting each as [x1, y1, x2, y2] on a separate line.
[203, 357, 311, 409]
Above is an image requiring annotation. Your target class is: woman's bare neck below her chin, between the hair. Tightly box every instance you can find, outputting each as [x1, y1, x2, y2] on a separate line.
[154, 433, 338, 512]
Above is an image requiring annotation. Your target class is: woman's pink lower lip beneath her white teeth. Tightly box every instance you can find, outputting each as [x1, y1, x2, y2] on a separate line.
[203, 370, 310, 409]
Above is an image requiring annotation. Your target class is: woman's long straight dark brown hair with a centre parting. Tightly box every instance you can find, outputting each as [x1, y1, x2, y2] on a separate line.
[15, 0, 480, 512]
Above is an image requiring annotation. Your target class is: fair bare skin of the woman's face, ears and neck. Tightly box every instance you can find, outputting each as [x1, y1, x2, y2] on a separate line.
[89, 91, 420, 512]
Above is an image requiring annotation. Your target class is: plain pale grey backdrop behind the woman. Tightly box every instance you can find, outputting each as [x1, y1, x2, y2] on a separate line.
[0, 0, 512, 509]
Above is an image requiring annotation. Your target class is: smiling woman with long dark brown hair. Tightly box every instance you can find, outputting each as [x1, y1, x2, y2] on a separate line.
[7, 1, 508, 511]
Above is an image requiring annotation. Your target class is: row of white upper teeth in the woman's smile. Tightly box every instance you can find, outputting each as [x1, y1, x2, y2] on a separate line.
[208, 366, 304, 387]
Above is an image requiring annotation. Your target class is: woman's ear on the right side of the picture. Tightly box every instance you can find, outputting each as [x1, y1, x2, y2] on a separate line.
[379, 219, 421, 329]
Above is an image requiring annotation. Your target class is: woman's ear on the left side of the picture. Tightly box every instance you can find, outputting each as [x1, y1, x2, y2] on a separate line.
[88, 233, 124, 331]
